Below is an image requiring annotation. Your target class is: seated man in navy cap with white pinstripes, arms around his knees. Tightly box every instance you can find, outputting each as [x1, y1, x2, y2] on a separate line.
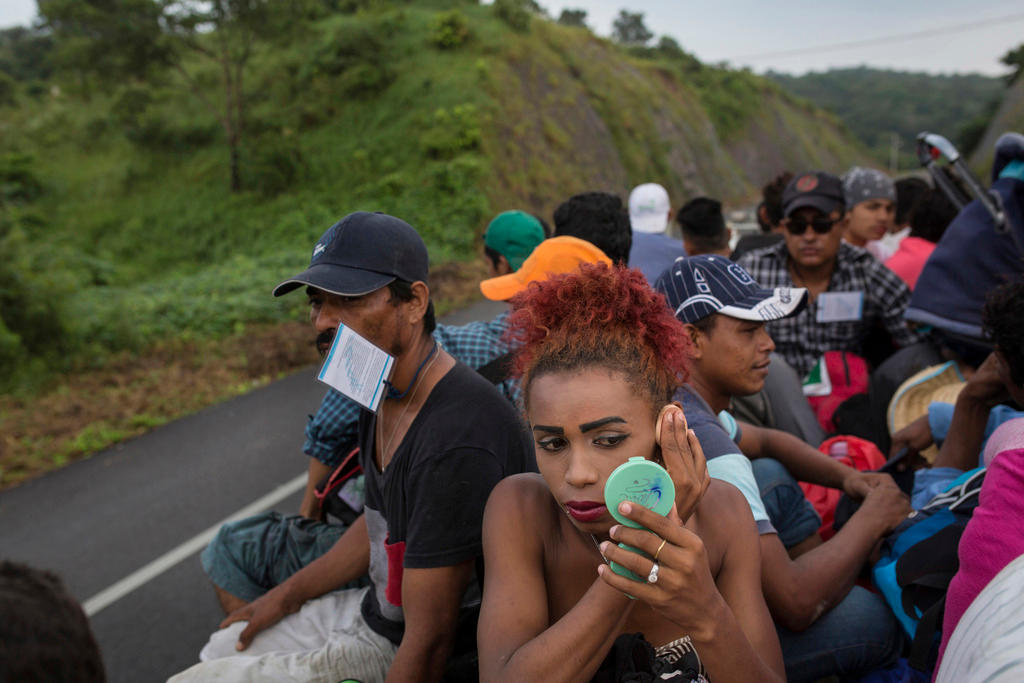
[654, 256, 909, 681]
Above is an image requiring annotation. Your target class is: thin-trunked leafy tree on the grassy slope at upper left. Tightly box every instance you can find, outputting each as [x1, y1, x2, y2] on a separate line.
[39, 0, 270, 191]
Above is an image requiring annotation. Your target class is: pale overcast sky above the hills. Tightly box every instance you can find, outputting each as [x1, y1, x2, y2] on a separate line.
[0, 0, 1024, 76]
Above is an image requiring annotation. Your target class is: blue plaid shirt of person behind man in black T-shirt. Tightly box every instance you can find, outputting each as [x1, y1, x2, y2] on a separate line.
[302, 311, 520, 467]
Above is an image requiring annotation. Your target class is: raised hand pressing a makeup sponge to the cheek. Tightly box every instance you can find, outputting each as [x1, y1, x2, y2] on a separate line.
[654, 403, 711, 524]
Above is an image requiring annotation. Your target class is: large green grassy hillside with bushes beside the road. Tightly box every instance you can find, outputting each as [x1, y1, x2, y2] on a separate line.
[0, 0, 863, 392]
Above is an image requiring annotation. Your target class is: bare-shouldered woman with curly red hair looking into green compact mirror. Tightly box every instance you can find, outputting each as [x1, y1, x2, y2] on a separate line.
[477, 264, 783, 682]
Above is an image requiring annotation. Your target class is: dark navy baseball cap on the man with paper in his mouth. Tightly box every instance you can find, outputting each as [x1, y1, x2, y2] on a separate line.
[273, 211, 429, 296]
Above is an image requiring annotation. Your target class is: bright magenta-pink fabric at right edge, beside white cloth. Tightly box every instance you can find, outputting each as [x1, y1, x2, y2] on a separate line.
[936, 449, 1024, 670]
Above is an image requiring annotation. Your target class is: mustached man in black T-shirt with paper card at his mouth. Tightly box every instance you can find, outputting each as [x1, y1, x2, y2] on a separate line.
[172, 212, 532, 681]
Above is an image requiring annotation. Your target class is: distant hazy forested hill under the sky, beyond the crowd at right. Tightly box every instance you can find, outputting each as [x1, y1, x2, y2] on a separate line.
[768, 67, 1005, 168]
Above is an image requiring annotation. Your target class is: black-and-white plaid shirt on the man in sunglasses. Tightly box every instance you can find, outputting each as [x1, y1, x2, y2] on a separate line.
[739, 242, 922, 377]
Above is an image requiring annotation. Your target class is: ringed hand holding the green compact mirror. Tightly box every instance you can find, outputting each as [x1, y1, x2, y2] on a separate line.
[598, 499, 724, 636]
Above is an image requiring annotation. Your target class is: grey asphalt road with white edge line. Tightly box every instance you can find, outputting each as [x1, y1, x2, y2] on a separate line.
[0, 301, 504, 683]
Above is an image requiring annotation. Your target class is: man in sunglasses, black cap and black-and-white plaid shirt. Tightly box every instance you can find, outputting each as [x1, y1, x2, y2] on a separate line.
[739, 171, 921, 377]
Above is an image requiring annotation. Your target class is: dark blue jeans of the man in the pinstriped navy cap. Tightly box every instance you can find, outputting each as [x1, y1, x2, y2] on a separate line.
[753, 458, 903, 682]
